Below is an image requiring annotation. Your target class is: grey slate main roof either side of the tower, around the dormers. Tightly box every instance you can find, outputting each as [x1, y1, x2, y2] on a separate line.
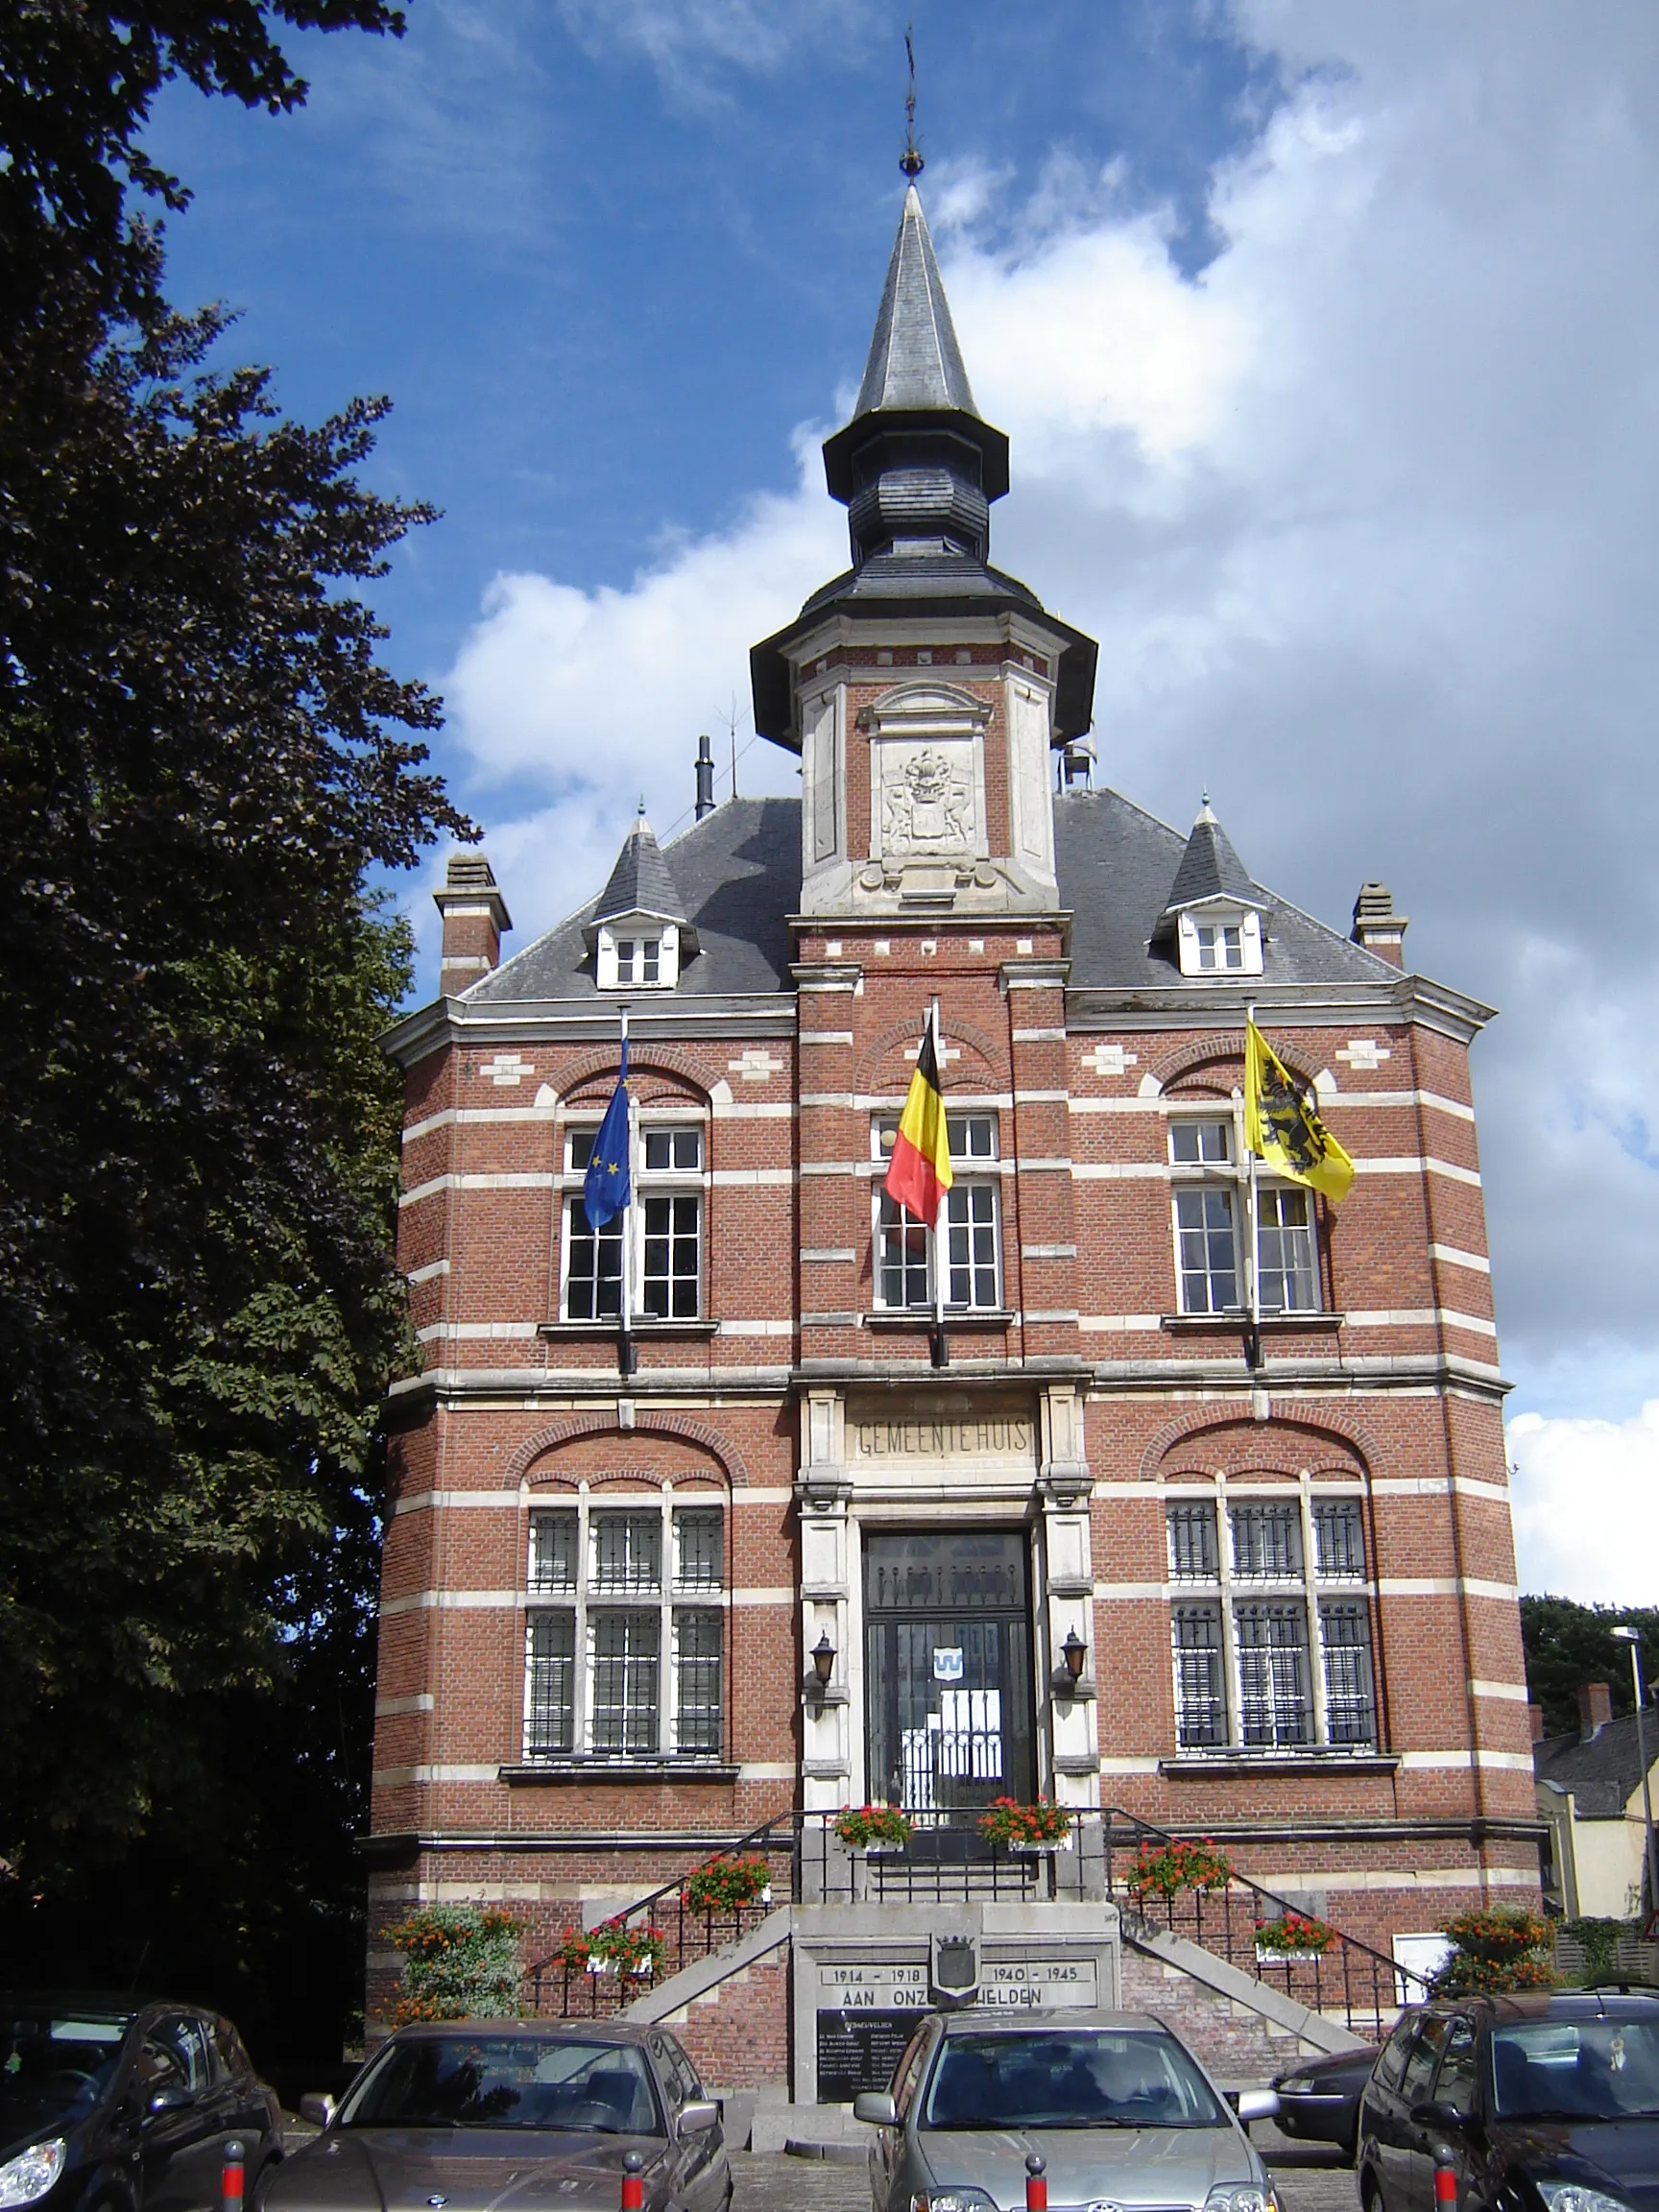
[467, 792, 1400, 1004]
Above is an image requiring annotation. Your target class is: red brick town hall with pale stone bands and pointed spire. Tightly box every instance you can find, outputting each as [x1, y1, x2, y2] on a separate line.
[372, 190, 1537, 2080]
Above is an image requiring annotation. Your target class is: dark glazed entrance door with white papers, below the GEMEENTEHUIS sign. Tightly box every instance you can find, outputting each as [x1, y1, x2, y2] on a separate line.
[865, 1528, 1035, 1825]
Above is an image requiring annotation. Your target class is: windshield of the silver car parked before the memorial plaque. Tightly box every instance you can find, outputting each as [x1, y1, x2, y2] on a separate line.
[920, 2029, 1228, 2128]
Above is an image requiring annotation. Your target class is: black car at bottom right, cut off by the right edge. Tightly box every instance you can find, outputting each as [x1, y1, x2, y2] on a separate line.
[1358, 1988, 1659, 2212]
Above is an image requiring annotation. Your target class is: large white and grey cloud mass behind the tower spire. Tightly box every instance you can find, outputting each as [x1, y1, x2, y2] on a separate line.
[445, 0, 1659, 1575]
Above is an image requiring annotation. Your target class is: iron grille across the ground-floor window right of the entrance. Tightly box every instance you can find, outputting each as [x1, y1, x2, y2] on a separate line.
[1168, 1484, 1378, 1752]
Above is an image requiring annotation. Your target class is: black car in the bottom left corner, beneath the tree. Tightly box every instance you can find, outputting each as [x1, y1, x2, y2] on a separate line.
[0, 1991, 283, 2212]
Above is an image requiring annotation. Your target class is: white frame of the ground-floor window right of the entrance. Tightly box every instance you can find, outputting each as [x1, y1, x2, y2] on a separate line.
[1164, 1478, 1382, 1759]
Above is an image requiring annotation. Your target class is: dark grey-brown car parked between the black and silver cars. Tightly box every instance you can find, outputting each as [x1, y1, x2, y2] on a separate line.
[265, 2020, 725, 2212]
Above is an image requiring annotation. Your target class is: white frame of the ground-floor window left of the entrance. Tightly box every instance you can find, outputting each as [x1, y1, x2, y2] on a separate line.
[522, 1484, 730, 1767]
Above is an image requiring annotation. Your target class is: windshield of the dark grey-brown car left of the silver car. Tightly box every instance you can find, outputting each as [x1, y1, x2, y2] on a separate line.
[341, 2031, 661, 2134]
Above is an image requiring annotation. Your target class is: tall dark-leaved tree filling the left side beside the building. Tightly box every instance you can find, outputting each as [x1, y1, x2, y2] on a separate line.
[0, 0, 469, 2026]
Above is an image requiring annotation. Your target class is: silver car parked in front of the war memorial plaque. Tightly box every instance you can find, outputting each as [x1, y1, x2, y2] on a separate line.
[854, 2007, 1279, 2212]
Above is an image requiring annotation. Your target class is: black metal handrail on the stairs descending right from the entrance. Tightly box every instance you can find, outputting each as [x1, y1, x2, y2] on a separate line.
[1101, 1805, 1429, 2039]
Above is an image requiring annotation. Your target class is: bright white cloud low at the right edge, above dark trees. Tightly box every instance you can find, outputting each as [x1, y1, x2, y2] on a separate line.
[1508, 1398, 1659, 1606]
